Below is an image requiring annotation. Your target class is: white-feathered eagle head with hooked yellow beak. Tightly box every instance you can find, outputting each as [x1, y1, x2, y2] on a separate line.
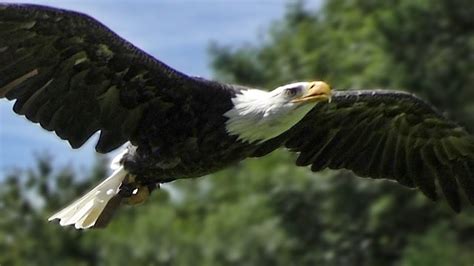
[224, 81, 331, 143]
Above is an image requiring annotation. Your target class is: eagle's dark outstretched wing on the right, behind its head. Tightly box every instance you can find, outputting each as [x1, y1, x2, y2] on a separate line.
[285, 91, 474, 211]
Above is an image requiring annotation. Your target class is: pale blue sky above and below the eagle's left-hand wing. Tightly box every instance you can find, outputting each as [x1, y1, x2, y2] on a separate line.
[0, 0, 321, 177]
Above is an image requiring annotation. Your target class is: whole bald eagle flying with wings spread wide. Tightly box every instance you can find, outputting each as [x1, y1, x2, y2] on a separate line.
[0, 4, 474, 228]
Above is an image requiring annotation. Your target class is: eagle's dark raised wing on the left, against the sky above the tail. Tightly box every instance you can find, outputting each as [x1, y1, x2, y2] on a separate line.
[0, 4, 228, 152]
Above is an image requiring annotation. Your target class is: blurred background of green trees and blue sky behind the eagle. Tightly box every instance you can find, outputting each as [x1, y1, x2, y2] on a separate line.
[0, 0, 474, 266]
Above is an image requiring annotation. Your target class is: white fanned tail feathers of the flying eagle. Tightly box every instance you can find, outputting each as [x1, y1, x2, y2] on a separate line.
[48, 164, 128, 229]
